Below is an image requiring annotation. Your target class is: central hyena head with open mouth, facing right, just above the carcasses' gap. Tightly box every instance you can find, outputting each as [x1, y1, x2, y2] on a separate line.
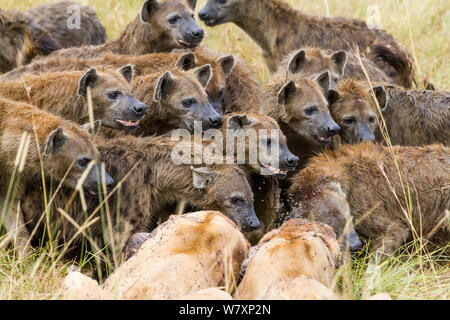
[222, 113, 298, 179]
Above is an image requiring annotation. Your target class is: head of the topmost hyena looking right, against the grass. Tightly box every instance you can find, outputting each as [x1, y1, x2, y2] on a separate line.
[141, 0, 205, 51]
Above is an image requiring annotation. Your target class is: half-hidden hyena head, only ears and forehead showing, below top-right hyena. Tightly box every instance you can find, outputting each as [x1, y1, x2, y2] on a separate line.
[279, 48, 347, 89]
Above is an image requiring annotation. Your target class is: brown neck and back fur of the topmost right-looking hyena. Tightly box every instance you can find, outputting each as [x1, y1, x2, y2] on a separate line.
[40, 0, 202, 59]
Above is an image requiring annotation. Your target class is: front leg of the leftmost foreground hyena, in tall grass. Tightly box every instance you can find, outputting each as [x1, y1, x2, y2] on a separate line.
[2, 202, 30, 259]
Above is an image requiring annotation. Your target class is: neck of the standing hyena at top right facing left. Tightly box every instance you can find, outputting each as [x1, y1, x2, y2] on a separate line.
[234, 0, 303, 58]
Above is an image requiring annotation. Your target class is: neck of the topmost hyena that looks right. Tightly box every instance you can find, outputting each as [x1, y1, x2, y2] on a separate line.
[114, 17, 169, 55]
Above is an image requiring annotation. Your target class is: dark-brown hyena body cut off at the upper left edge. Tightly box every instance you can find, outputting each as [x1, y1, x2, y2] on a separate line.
[0, 9, 61, 72]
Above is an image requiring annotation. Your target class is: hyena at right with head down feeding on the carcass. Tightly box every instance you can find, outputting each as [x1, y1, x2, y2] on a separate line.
[289, 143, 450, 254]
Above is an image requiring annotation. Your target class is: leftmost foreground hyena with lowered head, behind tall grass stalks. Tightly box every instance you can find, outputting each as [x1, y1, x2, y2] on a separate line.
[0, 99, 100, 255]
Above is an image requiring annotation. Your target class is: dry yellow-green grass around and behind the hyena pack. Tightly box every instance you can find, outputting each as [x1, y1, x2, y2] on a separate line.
[0, 0, 450, 299]
